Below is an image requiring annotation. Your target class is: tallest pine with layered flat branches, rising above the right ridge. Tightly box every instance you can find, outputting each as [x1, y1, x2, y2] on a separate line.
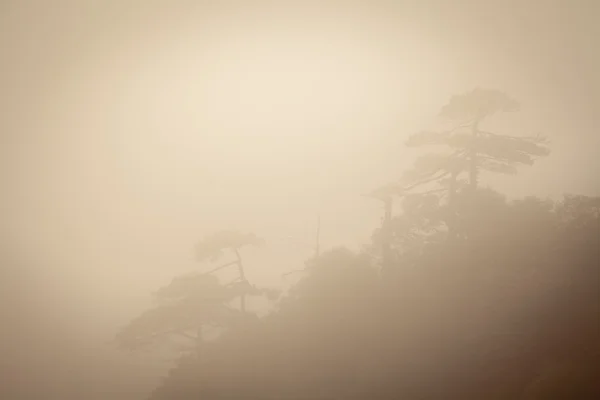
[402, 88, 549, 241]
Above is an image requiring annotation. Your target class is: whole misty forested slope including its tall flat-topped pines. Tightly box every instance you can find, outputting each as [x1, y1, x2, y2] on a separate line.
[115, 88, 600, 400]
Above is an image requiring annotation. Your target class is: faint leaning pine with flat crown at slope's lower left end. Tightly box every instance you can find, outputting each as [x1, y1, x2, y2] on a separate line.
[116, 231, 277, 350]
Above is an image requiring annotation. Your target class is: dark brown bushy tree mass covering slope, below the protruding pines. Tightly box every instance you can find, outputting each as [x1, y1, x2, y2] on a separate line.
[142, 189, 600, 400]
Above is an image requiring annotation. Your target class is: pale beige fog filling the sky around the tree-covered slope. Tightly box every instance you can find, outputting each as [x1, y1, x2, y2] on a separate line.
[0, 0, 600, 399]
